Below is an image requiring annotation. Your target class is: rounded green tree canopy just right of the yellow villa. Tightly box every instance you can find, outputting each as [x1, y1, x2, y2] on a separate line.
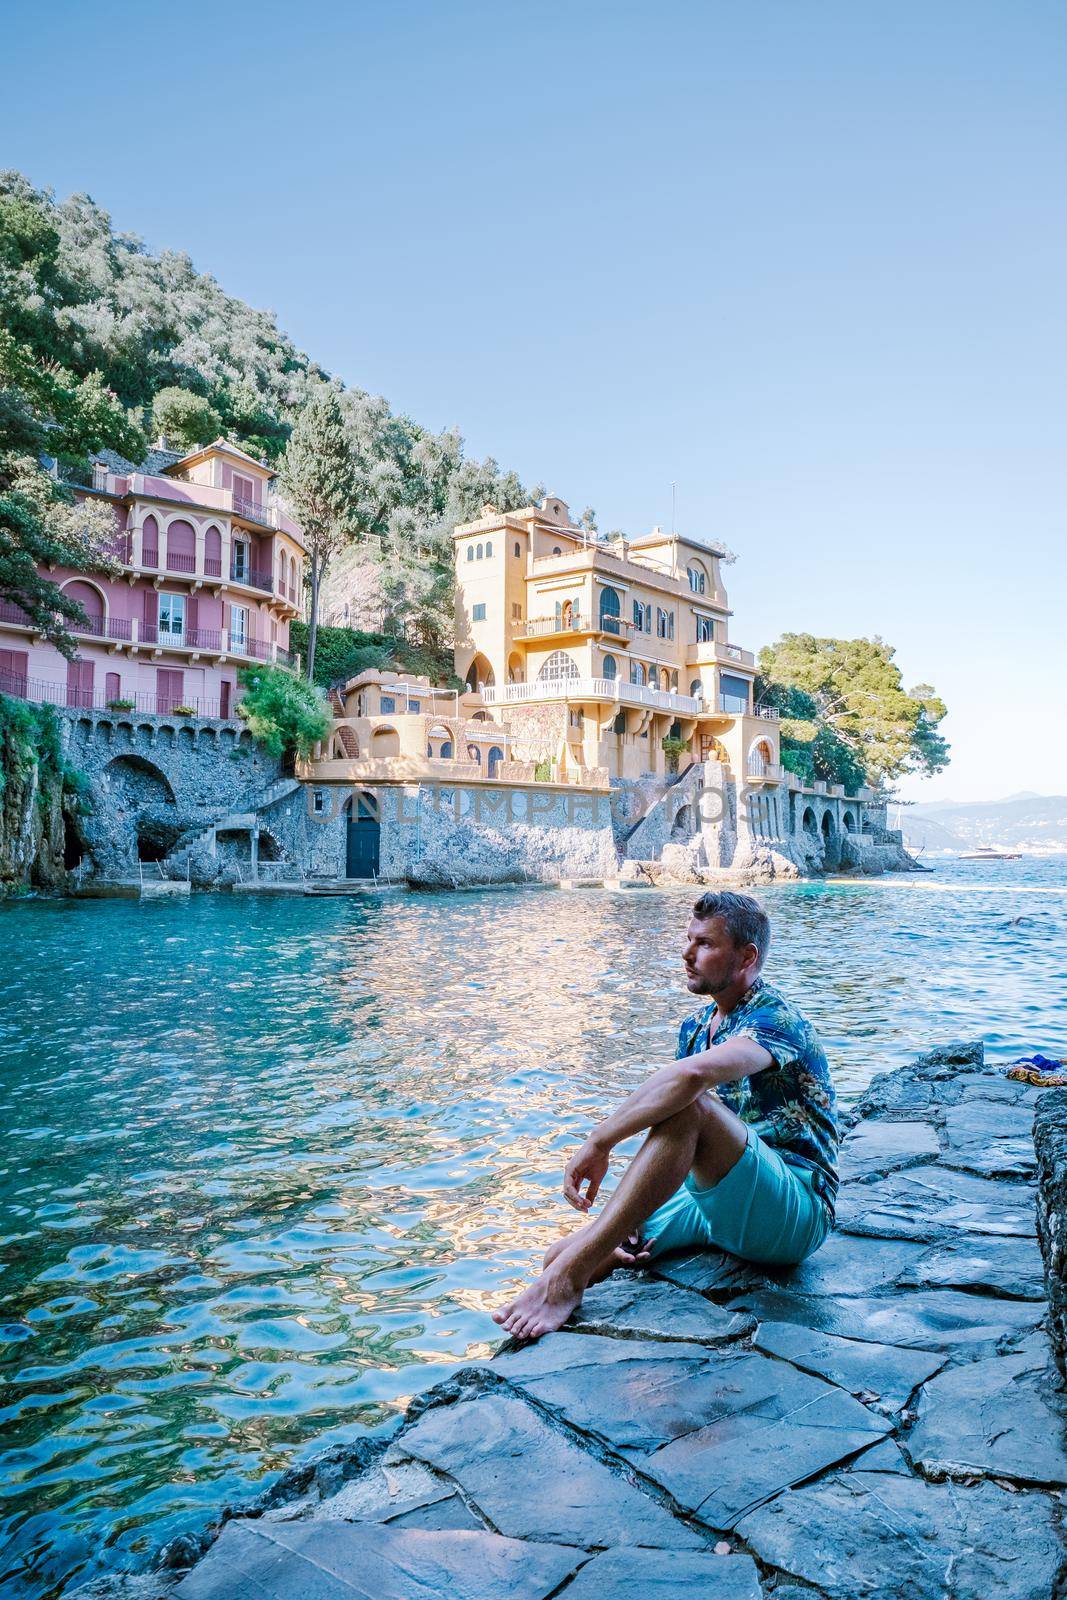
[757, 634, 949, 789]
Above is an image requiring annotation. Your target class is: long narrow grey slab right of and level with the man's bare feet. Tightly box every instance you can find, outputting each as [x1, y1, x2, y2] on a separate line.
[741, 1290, 1041, 1354]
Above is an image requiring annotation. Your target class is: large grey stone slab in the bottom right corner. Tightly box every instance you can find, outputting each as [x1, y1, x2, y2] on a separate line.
[737, 1472, 1062, 1600]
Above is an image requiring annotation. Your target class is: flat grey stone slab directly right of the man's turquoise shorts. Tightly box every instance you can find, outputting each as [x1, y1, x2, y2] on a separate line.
[837, 1165, 1037, 1243]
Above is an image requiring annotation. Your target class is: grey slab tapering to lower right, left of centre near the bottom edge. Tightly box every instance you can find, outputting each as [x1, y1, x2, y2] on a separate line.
[386, 1395, 704, 1550]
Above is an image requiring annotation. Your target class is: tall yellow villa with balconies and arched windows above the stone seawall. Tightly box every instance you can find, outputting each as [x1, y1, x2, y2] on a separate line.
[454, 498, 781, 784]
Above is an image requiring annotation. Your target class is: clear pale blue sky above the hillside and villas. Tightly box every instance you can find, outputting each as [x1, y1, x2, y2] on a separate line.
[0, 0, 1067, 798]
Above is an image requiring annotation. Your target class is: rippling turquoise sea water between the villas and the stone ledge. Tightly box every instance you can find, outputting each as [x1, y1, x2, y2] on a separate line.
[0, 858, 1067, 1597]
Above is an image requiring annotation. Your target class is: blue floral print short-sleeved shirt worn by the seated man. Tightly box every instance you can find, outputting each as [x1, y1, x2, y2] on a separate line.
[678, 978, 838, 1211]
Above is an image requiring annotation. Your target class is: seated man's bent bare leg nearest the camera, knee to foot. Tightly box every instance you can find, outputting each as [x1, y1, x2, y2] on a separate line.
[493, 1093, 747, 1339]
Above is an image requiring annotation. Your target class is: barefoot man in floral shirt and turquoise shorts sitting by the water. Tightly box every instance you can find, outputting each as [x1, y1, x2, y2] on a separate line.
[494, 893, 838, 1339]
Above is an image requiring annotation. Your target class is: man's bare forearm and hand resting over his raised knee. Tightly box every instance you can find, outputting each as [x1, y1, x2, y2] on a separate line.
[563, 1037, 774, 1211]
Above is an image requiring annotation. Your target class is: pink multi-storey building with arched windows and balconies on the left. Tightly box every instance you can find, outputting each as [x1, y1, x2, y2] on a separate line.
[0, 438, 304, 717]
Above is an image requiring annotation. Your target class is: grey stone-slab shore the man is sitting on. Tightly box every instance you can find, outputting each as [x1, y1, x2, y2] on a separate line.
[77, 1045, 1067, 1600]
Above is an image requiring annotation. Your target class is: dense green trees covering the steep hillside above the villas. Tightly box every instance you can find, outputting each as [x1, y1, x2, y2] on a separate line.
[0, 171, 531, 645]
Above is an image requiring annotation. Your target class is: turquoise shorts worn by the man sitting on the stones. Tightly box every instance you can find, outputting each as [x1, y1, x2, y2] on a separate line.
[641, 1128, 833, 1266]
